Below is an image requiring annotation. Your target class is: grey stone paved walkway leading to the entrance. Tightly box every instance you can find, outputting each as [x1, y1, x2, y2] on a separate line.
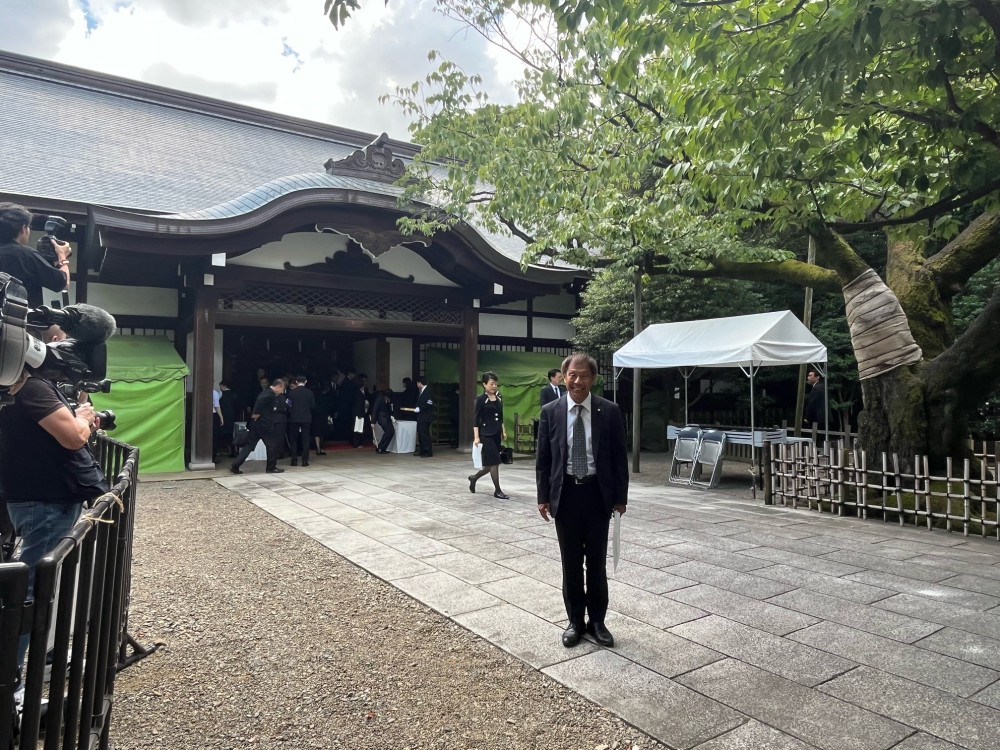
[217, 451, 1000, 750]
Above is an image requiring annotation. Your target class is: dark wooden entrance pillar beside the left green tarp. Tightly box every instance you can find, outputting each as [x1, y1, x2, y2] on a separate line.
[188, 286, 218, 471]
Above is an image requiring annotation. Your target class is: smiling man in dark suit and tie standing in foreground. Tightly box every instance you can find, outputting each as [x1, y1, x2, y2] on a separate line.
[535, 353, 629, 648]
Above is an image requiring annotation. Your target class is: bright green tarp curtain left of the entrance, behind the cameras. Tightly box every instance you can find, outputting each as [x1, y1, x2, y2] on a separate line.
[91, 336, 188, 474]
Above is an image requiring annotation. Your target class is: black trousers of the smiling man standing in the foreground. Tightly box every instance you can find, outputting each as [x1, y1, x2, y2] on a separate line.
[555, 476, 611, 625]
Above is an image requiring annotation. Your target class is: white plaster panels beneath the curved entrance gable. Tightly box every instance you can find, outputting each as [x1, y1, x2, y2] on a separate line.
[226, 232, 457, 287]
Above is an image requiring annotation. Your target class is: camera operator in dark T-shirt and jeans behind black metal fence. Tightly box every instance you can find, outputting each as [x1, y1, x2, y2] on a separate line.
[0, 368, 109, 670]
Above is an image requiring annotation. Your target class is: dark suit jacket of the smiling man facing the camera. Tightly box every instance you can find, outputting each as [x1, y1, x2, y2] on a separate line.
[535, 394, 629, 517]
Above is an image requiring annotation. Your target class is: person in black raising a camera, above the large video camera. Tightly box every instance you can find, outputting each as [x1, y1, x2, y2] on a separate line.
[0, 203, 70, 307]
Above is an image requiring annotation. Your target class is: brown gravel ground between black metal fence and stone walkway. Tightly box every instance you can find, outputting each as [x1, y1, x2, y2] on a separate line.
[111, 480, 664, 750]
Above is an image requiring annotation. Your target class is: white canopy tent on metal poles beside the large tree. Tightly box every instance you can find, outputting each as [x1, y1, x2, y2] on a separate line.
[612, 310, 830, 470]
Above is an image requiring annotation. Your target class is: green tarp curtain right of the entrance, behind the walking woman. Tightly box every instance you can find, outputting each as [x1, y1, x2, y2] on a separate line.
[426, 349, 604, 444]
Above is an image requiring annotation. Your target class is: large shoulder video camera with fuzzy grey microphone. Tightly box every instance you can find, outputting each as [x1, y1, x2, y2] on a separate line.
[0, 273, 117, 407]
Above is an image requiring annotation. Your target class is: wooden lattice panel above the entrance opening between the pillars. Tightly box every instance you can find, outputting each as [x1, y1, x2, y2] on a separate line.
[219, 284, 462, 325]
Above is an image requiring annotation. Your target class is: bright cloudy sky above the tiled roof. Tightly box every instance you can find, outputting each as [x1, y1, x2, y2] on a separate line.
[0, 0, 518, 140]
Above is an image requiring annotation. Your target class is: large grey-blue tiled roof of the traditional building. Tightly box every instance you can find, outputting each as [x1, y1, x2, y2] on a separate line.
[0, 53, 580, 268]
